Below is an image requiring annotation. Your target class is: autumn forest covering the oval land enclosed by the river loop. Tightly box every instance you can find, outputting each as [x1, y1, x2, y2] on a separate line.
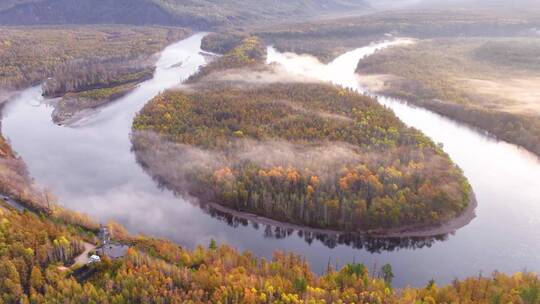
[133, 38, 471, 231]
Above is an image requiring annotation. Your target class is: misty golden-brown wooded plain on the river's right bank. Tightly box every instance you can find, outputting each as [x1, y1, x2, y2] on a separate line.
[358, 38, 540, 154]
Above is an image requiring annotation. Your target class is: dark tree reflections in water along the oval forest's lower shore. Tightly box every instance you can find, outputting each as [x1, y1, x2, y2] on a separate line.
[135, 147, 448, 253]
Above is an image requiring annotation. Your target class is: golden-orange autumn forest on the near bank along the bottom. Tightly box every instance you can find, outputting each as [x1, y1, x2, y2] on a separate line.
[0, 202, 540, 304]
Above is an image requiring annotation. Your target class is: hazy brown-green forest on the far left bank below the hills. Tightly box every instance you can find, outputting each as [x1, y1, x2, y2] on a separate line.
[0, 26, 189, 122]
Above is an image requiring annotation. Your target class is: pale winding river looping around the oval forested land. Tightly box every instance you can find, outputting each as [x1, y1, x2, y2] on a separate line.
[2, 34, 540, 286]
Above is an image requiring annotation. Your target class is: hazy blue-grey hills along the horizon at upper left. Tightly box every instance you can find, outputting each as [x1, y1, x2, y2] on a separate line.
[0, 0, 368, 29]
